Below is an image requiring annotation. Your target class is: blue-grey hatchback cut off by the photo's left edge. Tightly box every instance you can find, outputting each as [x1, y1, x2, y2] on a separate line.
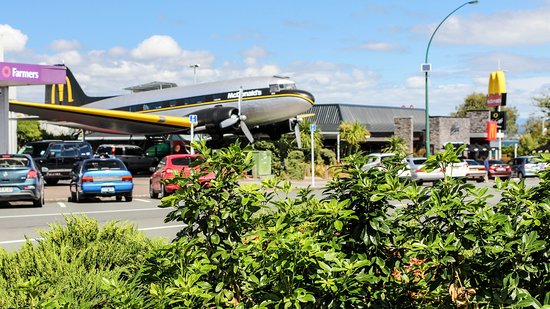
[0, 154, 44, 207]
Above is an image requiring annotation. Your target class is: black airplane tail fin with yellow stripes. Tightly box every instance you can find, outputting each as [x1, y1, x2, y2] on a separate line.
[44, 64, 109, 106]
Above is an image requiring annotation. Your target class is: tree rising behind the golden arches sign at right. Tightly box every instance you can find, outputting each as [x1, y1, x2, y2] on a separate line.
[451, 92, 519, 135]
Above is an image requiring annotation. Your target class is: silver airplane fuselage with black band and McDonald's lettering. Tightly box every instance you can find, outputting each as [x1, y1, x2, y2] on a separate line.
[83, 77, 314, 126]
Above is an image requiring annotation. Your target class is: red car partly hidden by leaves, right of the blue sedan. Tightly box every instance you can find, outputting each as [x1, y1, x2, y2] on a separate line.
[149, 154, 214, 198]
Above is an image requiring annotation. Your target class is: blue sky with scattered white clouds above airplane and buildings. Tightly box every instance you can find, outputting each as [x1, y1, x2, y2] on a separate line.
[0, 0, 550, 119]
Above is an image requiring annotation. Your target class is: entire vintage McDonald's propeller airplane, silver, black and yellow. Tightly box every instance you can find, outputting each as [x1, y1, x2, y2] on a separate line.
[10, 68, 315, 143]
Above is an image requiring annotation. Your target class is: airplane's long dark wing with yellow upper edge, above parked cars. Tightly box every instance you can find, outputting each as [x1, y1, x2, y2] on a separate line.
[10, 101, 191, 135]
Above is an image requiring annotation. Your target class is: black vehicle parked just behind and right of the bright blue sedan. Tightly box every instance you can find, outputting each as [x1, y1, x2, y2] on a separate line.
[95, 144, 155, 173]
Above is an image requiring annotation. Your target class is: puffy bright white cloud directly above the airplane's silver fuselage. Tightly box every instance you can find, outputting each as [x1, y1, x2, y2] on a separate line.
[132, 35, 182, 60]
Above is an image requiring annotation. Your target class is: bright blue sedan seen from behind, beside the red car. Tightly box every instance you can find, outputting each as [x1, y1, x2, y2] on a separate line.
[69, 158, 134, 203]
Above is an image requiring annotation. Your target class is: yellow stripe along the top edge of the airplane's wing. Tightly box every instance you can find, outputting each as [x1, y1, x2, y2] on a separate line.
[10, 101, 191, 128]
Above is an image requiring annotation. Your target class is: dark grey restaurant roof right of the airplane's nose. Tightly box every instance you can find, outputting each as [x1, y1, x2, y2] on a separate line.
[306, 103, 426, 133]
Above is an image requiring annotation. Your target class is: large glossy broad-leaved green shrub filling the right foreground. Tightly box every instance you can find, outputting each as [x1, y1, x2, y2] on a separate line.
[7, 144, 550, 308]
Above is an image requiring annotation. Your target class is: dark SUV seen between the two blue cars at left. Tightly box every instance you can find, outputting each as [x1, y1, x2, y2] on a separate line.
[19, 140, 93, 185]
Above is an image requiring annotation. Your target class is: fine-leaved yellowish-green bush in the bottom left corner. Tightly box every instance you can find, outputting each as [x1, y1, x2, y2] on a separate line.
[0, 217, 160, 308]
